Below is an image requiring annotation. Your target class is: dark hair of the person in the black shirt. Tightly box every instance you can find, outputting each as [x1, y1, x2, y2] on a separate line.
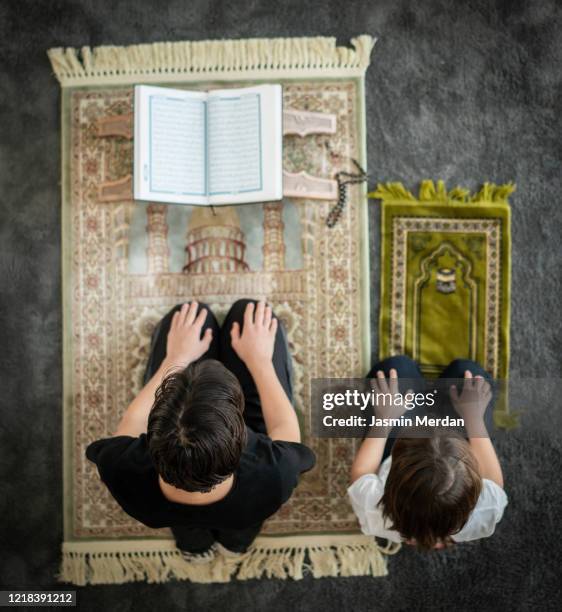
[147, 359, 246, 493]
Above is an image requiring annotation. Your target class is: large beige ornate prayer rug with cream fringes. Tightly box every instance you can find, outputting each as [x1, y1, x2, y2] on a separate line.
[49, 36, 392, 584]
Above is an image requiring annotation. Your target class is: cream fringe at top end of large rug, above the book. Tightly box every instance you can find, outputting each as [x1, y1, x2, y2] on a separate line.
[47, 34, 375, 87]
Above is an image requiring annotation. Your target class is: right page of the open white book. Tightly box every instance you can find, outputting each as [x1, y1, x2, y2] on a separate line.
[207, 85, 283, 204]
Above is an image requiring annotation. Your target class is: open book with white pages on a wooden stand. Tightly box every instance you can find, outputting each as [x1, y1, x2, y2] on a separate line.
[133, 85, 283, 206]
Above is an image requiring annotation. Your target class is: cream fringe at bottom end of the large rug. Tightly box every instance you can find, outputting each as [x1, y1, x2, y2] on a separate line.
[58, 534, 400, 585]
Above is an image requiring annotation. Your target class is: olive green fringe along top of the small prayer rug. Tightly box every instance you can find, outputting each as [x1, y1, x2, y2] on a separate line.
[367, 180, 515, 204]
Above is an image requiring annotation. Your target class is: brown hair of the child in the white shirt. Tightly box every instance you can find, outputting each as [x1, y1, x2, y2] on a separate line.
[379, 432, 482, 550]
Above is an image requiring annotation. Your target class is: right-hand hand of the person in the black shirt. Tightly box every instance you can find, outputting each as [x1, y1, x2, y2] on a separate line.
[230, 301, 277, 371]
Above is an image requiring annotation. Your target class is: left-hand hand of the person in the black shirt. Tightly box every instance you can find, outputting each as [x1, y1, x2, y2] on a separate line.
[166, 302, 213, 367]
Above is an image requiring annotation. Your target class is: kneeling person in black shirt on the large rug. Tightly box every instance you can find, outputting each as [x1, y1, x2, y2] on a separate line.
[86, 300, 315, 560]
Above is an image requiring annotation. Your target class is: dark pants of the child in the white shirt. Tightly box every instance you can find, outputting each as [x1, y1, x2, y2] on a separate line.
[367, 355, 496, 462]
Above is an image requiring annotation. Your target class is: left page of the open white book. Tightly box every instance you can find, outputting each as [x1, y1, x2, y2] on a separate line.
[134, 86, 208, 204]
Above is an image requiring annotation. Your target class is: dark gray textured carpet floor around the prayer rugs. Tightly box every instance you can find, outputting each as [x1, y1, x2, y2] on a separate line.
[0, 0, 562, 611]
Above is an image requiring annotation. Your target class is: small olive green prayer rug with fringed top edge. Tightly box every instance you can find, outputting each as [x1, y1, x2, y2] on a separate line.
[369, 180, 516, 427]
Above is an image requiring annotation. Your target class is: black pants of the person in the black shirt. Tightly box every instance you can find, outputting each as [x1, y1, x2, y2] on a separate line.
[144, 300, 293, 553]
